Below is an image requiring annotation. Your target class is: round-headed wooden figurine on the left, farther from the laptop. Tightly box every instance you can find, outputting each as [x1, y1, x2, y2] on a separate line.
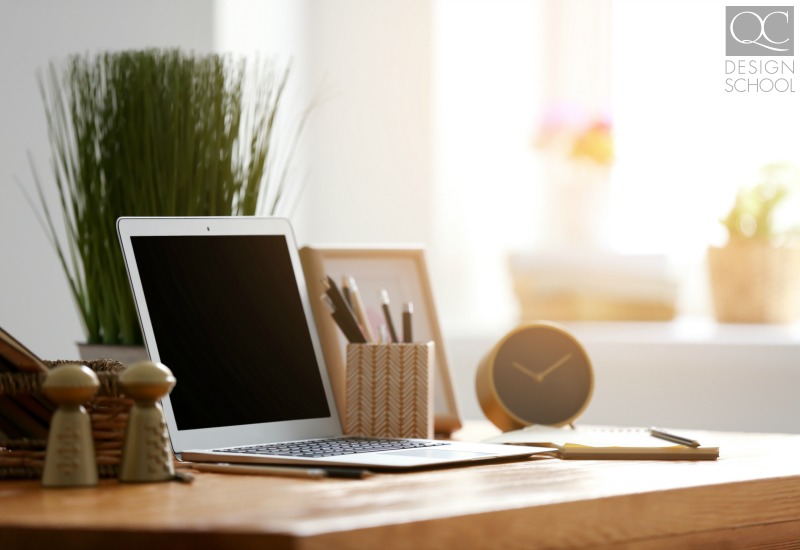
[42, 364, 100, 487]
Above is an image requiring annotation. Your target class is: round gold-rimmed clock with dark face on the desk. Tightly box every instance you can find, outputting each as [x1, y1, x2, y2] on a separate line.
[476, 321, 594, 431]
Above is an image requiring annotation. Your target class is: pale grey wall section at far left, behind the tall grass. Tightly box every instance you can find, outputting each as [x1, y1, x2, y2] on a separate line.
[0, 0, 213, 359]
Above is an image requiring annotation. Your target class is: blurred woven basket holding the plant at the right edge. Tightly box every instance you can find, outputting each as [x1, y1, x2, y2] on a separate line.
[708, 244, 800, 323]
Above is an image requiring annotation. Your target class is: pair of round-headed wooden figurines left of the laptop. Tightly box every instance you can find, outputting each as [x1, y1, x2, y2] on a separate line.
[42, 361, 175, 487]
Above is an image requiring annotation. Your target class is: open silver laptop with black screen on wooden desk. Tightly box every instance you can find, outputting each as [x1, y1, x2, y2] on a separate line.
[117, 217, 549, 469]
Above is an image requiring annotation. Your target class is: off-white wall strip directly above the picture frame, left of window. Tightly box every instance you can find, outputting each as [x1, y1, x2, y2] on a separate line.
[297, 0, 433, 248]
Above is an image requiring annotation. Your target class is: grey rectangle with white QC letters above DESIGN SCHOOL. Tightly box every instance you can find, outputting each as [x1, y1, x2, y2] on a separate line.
[725, 6, 794, 56]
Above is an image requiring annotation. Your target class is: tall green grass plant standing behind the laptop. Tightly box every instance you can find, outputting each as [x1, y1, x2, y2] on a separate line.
[34, 49, 308, 359]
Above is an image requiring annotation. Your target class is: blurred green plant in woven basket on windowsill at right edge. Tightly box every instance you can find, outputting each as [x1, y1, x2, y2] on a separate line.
[708, 164, 800, 323]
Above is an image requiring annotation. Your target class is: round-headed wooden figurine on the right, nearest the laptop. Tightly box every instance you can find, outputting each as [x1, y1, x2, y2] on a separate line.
[119, 361, 175, 483]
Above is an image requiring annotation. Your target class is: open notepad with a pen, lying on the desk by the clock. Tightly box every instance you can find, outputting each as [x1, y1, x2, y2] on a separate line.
[487, 425, 719, 460]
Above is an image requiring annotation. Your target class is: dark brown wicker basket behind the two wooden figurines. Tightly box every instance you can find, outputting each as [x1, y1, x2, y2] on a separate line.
[0, 359, 133, 479]
